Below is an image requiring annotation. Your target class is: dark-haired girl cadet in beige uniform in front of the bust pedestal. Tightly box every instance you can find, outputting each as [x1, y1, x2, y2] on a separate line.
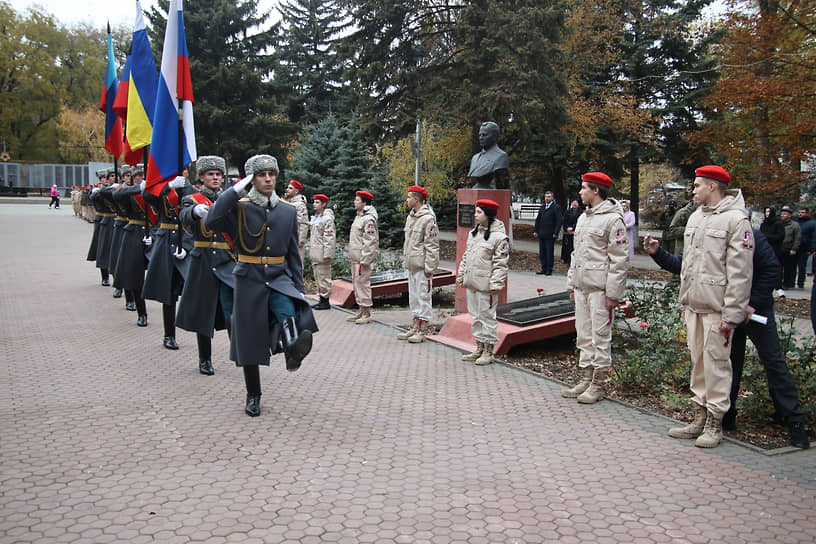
[456, 199, 510, 365]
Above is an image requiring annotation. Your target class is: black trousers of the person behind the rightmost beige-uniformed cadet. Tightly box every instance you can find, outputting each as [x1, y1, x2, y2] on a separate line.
[725, 308, 805, 423]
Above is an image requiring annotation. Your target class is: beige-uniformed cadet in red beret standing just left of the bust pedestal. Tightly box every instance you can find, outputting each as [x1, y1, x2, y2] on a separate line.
[397, 185, 439, 343]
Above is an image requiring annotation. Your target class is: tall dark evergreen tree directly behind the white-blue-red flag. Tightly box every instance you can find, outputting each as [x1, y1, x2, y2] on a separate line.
[148, 0, 297, 173]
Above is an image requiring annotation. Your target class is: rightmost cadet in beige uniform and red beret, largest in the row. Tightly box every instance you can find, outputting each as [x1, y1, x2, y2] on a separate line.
[669, 166, 754, 448]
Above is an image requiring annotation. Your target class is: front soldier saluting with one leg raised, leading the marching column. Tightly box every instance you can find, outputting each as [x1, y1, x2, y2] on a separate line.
[204, 155, 317, 417]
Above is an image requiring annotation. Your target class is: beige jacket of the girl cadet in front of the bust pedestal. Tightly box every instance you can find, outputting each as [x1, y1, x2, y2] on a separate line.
[456, 219, 510, 293]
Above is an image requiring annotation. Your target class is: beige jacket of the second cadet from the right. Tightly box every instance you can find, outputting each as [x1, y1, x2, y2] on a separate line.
[567, 198, 629, 300]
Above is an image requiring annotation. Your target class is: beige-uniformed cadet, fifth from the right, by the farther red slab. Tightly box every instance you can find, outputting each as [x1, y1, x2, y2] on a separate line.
[346, 191, 380, 325]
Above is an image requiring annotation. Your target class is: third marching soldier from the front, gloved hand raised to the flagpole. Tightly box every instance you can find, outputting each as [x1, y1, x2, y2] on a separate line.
[142, 168, 193, 349]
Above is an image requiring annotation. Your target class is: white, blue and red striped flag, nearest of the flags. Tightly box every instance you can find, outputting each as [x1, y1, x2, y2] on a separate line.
[145, 0, 197, 196]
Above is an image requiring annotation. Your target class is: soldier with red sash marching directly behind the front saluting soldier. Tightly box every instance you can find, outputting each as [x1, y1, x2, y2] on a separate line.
[176, 155, 235, 376]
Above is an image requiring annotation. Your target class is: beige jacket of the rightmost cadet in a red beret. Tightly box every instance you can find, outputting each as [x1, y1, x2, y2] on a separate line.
[679, 189, 754, 323]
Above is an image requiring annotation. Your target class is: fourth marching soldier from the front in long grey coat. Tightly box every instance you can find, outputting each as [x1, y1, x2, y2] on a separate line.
[113, 166, 149, 327]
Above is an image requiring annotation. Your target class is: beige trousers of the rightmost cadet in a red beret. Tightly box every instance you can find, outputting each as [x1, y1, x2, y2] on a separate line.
[684, 309, 733, 417]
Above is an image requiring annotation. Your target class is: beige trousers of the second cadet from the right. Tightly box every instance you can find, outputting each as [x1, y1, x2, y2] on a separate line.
[573, 289, 614, 368]
